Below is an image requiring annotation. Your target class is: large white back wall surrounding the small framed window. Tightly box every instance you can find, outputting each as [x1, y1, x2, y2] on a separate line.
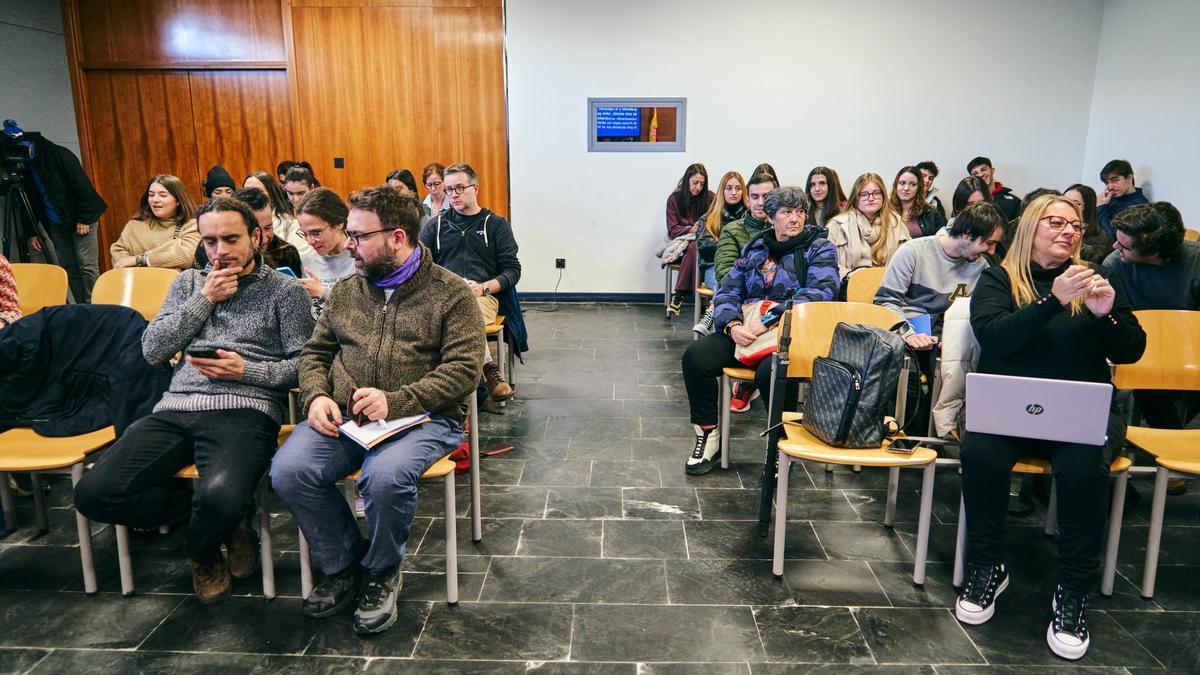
[505, 0, 1104, 293]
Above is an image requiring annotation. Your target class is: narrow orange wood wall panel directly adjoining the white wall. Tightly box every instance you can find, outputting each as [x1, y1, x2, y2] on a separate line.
[433, 7, 509, 216]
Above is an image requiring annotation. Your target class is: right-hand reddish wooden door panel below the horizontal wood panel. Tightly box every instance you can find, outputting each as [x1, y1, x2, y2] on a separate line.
[190, 71, 295, 186]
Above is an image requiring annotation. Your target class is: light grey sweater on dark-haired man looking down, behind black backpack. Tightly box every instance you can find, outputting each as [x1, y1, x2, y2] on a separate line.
[875, 234, 988, 334]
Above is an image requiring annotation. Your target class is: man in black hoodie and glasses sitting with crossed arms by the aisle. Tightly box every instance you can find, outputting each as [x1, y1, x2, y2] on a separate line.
[420, 163, 521, 401]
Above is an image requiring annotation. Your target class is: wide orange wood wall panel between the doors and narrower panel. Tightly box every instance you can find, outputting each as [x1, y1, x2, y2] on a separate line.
[292, 7, 444, 195]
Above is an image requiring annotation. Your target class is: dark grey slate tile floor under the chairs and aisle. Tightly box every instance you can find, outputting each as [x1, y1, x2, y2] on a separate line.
[0, 304, 1200, 675]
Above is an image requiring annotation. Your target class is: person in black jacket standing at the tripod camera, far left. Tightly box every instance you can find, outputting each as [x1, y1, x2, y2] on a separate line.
[14, 129, 108, 303]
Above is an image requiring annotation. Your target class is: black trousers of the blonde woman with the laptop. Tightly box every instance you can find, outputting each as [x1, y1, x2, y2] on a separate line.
[961, 403, 1124, 593]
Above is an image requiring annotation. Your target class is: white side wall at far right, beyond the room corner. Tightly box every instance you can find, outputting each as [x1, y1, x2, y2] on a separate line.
[1082, 0, 1200, 229]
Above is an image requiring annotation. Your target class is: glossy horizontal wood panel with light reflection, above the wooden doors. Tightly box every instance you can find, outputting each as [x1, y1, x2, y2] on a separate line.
[74, 0, 287, 70]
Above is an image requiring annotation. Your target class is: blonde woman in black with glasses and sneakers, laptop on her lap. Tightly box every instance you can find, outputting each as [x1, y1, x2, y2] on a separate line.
[955, 195, 1146, 659]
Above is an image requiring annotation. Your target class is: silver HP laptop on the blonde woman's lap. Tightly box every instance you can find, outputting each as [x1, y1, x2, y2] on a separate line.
[966, 372, 1112, 446]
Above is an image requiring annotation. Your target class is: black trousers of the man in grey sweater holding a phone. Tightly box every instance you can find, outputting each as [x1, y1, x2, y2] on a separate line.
[74, 410, 280, 565]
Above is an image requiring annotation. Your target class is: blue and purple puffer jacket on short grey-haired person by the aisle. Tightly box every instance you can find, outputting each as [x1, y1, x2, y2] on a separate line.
[713, 228, 841, 330]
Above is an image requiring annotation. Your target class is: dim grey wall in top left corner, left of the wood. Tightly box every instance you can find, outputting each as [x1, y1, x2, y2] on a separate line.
[0, 0, 79, 156]
